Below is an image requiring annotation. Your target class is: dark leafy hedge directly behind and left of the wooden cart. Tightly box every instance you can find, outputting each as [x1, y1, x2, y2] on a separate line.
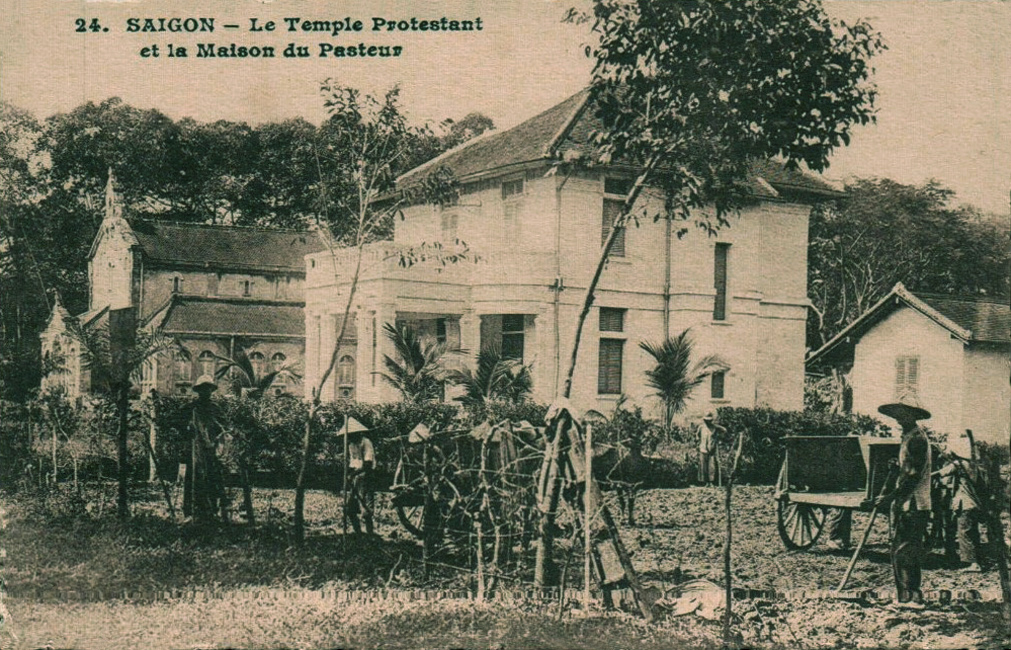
[718, 406, 889, 484]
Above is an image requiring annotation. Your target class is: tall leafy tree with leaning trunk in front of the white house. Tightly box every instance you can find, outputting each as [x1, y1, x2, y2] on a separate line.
[535, 0, 883, 583]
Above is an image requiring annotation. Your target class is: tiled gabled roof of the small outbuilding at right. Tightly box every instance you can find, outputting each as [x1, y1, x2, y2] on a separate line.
[807, 282, 1011, 368]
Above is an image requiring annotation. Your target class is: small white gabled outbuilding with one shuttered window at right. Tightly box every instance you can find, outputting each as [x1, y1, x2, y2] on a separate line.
[807, 283, 1011, 452]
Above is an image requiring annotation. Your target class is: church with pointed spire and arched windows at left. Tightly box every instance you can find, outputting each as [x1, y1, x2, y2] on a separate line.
[41, 175, 323, 397]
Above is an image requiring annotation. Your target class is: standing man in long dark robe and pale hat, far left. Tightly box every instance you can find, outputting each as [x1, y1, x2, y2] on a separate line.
[183, 375, 227, 522]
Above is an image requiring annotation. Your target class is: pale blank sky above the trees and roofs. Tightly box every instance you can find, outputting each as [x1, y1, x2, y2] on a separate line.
[0, 0, 1011, 214]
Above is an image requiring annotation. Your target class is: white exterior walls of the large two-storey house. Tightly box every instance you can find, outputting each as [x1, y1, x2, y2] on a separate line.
[305, 170, 810, 413]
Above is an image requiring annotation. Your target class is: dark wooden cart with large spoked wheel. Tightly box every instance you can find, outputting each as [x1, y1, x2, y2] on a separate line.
[775, 436, 944, 551]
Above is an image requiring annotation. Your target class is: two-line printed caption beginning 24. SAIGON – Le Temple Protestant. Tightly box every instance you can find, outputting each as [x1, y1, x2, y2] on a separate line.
[74, 16, 484, 60]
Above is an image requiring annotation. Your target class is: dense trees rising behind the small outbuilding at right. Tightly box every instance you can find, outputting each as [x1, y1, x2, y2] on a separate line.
[808, 179, 1011, 348]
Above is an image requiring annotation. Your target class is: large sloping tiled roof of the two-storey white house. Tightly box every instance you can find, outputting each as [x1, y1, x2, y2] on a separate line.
[397, 89, 842, 197]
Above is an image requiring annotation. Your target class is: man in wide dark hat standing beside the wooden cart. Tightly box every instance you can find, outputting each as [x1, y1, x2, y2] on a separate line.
[878, 394, 930, 610]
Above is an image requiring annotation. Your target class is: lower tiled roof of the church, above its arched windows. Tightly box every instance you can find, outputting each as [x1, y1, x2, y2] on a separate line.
[156, 295, 305, 338]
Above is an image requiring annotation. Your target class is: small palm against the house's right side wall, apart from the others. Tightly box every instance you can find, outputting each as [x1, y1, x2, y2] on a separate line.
[639, 330, 728, 431]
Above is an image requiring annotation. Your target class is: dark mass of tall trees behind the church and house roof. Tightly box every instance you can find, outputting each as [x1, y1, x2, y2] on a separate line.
[0, 98, 493, 399]
